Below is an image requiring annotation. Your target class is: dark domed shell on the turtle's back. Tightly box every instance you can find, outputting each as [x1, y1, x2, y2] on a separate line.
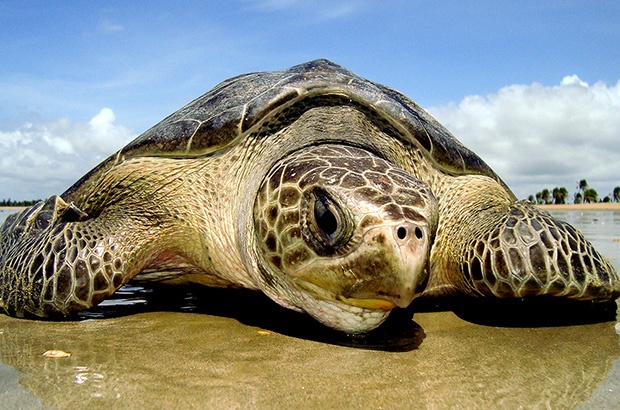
[63, 59, 501, 196]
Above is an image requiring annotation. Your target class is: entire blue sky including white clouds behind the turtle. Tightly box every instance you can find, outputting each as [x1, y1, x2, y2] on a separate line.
[0, 0, 620, 199]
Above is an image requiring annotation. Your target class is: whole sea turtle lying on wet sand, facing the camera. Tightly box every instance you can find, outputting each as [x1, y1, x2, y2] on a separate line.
[0, 60, 620, 333]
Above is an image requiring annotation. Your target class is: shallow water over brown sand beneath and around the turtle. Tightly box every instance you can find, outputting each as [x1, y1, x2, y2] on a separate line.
[0, 211, 620, 409]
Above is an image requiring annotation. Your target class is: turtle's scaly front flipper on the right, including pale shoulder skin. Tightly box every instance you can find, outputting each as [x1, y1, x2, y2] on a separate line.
[425, 176, 620, 301]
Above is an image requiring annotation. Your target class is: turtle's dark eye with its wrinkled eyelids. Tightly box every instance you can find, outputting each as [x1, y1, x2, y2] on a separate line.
[307, 189, 351, 254]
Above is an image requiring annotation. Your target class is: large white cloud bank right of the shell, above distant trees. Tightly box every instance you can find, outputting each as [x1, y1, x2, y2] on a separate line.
[429, 75, 620, 202]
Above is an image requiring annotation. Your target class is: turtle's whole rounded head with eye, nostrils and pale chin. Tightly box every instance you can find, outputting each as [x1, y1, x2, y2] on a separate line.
[254, 145, 437, 333]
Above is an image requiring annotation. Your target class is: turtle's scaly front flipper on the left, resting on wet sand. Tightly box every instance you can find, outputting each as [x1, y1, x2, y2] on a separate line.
[0, 196, 155, 317]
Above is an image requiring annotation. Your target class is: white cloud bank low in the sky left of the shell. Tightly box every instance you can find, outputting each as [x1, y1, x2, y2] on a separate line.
[0, 108, 135, 200]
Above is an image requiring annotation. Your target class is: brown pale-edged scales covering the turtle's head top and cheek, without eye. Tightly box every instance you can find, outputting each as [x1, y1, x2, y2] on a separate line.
[254, 145, 437, 278]
